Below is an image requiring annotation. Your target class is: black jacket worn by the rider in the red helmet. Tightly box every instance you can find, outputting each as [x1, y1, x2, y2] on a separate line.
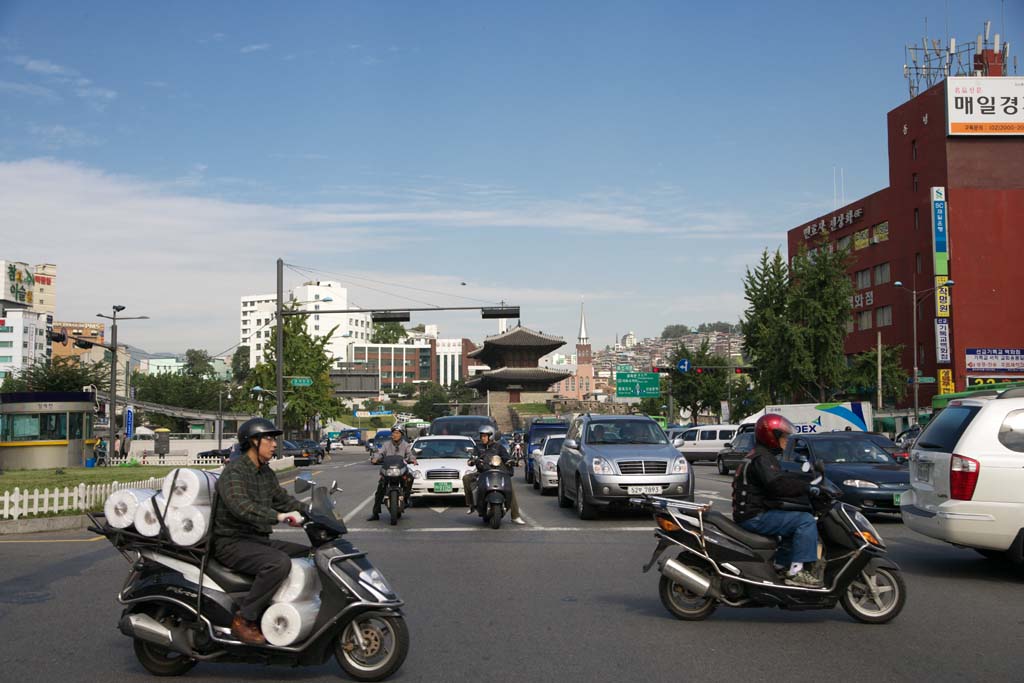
[732, 443, 810, 522]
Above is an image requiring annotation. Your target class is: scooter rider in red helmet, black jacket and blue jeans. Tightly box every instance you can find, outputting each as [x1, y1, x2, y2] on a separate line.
[732, 413, 821, 588]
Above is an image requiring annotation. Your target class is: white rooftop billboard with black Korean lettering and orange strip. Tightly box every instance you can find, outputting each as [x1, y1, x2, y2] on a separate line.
[946, 76, 1024, 135]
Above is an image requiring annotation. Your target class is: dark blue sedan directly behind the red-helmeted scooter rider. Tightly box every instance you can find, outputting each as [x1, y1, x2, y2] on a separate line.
[782, 432, 910, 513]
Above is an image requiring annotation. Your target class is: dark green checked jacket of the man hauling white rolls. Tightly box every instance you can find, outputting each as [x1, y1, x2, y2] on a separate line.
[213, 453, 309, 537]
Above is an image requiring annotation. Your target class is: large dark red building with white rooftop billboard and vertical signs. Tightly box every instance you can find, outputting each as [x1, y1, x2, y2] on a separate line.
[787, 53, 1024, 408]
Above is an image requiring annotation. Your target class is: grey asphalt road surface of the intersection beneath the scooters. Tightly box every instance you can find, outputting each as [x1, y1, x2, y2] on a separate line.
[0, 449, 1024, 682]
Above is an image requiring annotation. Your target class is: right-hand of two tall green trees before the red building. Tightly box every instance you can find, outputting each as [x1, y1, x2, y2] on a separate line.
[787, 238, 853, 401]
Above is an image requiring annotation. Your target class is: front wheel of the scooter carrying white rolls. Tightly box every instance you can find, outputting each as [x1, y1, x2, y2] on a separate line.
[334, 614, 409, 681]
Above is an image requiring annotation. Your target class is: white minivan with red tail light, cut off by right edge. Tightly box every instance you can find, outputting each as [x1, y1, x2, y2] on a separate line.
[900, 389, 1024, 562]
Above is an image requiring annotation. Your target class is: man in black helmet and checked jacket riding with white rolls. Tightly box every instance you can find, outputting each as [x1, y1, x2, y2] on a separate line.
[213, 418, 309, 645]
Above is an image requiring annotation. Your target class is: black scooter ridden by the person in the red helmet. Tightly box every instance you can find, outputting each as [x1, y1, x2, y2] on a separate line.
[631, 461, 906, 624]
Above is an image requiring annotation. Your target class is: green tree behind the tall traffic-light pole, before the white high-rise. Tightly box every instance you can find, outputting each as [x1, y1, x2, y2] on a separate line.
[234, 306, 343, 431]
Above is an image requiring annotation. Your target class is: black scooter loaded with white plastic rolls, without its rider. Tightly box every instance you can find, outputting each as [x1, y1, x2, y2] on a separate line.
[89, 475, 409, 681]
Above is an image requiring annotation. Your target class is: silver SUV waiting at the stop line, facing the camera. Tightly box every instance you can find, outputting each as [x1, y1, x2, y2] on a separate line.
[558, 413, 693, 519]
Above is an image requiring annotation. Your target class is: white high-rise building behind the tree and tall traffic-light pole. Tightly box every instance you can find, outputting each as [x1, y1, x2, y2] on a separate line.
[239, 281, 374, 368]
